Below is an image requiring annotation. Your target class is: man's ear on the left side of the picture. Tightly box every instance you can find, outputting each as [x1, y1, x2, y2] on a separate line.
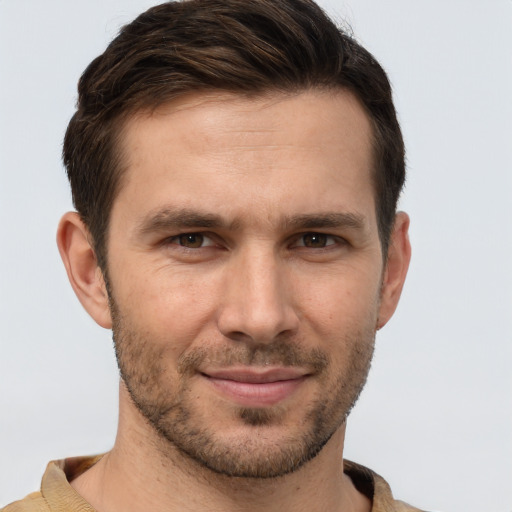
[57, 212, 112, 329]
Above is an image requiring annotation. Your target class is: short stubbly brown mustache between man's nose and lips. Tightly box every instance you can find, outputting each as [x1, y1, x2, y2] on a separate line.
[178, 340, 329, 375]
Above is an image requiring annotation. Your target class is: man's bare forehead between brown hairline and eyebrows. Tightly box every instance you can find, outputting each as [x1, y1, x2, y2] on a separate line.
[113, 90, 374, 230]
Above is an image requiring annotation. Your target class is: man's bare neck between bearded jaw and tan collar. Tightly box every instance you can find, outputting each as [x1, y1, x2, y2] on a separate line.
[72, 384, 370, 512]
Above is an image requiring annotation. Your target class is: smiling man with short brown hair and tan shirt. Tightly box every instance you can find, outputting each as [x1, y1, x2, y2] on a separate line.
[4, 0, 416, 512]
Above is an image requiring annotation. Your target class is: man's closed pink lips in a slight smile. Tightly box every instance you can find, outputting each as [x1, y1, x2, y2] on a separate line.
[201, 367, 309, 407]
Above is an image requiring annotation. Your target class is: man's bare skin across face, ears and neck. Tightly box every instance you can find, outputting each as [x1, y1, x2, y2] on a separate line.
[58, 90, 410, 512]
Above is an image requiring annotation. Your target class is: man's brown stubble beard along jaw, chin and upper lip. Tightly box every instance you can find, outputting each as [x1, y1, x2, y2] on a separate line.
[110, 294, 375, 478]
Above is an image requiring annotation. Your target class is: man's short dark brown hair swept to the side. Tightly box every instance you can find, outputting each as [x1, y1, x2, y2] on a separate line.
[63, 0, 405, 270]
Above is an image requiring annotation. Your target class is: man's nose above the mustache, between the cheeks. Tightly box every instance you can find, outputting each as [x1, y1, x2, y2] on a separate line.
[218, 245, 299, 344]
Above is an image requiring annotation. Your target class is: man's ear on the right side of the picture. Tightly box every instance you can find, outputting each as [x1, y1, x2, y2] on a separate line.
[377, 212, 411, 329]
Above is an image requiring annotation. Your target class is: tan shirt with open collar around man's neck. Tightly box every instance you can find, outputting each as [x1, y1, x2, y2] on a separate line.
[0, 455, 421, 512]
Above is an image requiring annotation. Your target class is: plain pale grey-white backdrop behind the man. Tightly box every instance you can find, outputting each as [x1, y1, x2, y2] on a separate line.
[0, 0, 512, 512]
